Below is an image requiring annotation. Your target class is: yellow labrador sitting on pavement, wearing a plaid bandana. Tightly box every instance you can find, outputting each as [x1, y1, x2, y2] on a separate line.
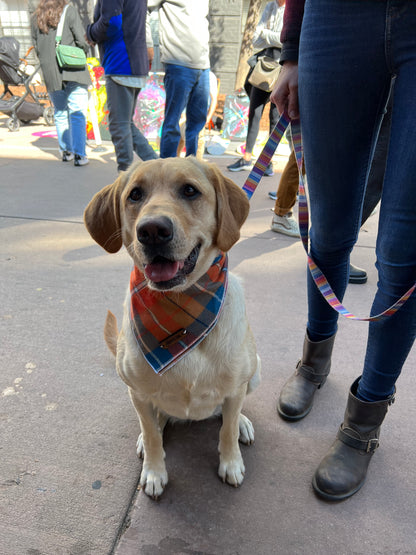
[84, 157, 260, 498]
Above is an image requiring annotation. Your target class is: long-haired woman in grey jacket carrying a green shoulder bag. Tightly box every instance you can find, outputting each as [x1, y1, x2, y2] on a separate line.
[31, 0, 91, 166]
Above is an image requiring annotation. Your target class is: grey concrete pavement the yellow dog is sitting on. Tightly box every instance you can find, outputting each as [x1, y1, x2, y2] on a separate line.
[0, 117, 416, 555]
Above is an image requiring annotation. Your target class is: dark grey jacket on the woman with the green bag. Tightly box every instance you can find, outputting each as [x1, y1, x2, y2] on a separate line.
[31, 5, 91, 92]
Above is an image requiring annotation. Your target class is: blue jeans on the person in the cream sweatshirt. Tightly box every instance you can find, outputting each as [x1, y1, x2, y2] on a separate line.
[160, 64, 209, 158]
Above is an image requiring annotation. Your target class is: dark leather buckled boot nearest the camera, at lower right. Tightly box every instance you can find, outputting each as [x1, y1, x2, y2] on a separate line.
[312, 378, 394, 501]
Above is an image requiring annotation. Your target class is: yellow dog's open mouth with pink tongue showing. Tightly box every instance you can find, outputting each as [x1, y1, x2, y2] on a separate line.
[144, 245, 201, 288]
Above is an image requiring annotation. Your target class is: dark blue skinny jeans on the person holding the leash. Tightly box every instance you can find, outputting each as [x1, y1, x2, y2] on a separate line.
[299, 0, 416, 401]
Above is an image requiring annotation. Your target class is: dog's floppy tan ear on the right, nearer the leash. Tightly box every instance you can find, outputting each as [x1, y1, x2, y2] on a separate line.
[209, 166, 250, 252]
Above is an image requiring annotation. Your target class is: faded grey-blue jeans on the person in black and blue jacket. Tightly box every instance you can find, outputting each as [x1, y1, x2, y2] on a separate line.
[105, 76, 157, 171]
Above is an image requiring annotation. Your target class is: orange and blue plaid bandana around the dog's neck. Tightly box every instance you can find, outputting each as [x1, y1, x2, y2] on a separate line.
[130, 253, 228, 374]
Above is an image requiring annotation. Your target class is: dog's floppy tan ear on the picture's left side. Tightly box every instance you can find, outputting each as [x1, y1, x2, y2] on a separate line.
[84, 172, 127, 253]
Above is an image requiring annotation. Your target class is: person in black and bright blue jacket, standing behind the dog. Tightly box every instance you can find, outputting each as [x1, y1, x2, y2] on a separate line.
[86, 0, 157, 172]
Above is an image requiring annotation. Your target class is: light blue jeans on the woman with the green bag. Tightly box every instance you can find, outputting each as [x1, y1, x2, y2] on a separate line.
[49, 81, 88, 156]
